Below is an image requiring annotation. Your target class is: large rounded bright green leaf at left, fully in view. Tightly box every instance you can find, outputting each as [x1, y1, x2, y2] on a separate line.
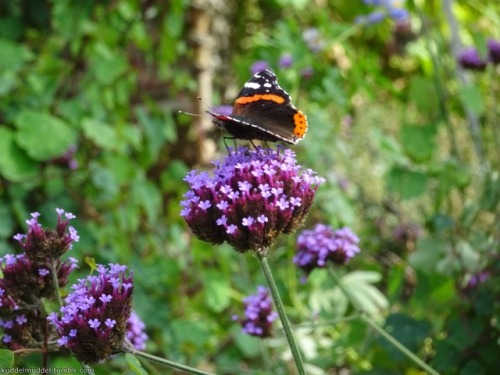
[15, 110, 77, 161]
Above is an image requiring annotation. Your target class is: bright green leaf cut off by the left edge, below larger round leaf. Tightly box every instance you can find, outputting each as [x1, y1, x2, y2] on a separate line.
[0, 128, 38, 181]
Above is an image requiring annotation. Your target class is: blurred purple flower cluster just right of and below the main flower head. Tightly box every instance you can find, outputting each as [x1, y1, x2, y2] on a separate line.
[293, 224, 360, 275]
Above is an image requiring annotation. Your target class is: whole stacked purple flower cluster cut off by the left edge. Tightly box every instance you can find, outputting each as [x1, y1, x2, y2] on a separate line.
[0, 209, 79, 350]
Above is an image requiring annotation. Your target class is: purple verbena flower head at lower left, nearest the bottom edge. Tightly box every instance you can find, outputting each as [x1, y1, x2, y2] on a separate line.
[48, 264, 134, 363]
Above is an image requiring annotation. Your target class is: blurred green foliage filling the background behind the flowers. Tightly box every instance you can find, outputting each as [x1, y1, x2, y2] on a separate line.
[0, 0, 500, 375]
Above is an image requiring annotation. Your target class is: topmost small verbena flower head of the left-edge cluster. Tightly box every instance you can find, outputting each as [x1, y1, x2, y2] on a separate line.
[14, 208, 80, 262]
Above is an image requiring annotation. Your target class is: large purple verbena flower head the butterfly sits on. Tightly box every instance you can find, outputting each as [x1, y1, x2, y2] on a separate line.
[181, 148, 323, 253]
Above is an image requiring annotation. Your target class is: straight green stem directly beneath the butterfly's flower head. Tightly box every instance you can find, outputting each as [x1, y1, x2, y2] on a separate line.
[257, 254, 305, 375]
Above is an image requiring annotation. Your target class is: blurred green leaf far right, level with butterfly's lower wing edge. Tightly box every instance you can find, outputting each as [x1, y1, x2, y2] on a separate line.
[401, 125, 437, 163]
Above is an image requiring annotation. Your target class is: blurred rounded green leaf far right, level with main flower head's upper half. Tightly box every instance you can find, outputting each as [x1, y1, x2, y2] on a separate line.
[387, 167, 427, 199]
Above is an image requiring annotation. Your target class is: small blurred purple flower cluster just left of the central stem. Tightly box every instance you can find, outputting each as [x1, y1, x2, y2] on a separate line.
[233, 286, 278, 337]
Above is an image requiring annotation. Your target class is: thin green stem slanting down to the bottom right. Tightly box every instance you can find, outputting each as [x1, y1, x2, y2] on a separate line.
[328, 268, 439, 375]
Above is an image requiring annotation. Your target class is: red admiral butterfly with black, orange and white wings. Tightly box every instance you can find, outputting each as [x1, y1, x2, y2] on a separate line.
[207, 70, 307, 144]
